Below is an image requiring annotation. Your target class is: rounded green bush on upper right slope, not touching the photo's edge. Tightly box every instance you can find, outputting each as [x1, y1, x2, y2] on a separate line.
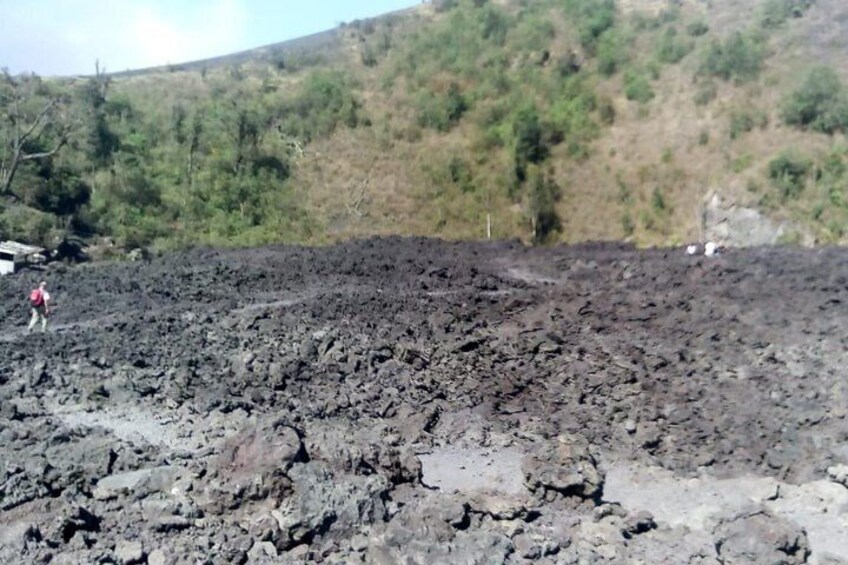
[700, 32, 765, 83]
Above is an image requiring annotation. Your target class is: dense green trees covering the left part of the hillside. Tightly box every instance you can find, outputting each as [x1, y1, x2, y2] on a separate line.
[0, 58, 361, 246]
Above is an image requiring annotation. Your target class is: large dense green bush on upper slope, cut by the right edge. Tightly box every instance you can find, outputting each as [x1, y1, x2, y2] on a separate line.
[782, 67, 848, 134]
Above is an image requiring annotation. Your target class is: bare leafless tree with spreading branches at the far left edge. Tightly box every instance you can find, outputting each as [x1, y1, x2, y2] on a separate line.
[0, 69, 73, 194]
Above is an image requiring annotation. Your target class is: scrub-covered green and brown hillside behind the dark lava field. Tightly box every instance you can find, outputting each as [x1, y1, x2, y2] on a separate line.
[0, 0, 848, 248]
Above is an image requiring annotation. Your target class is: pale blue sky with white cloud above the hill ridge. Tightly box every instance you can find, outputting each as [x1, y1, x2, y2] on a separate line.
[0, 0, 421, 76]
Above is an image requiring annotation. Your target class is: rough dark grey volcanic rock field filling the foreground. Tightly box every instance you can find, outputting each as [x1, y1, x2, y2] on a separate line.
[0, 238, 848, 565]
